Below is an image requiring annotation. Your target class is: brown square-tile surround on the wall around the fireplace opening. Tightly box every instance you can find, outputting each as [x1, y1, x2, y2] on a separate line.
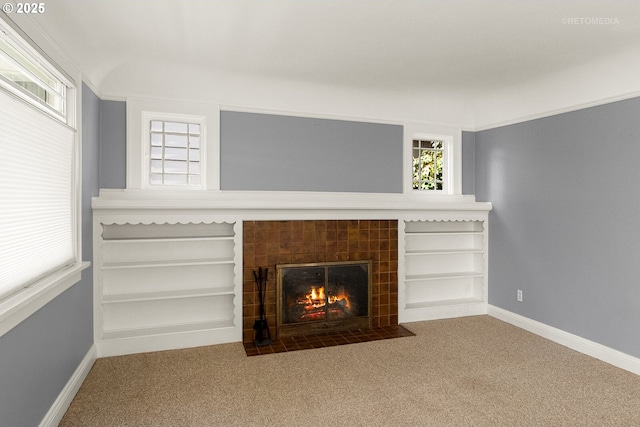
[242, 220, 398, 342]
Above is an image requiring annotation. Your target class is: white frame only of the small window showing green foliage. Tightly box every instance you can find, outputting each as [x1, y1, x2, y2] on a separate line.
[403, 123, 462, 196]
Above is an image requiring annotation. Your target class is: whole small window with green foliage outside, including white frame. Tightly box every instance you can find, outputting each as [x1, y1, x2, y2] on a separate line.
[404, 123, 462, 196]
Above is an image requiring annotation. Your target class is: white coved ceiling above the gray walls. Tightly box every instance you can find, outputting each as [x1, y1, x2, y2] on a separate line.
[22, 0, 640, 126]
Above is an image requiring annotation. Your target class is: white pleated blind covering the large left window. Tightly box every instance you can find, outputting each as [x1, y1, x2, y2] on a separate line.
[0, 90, 75, 299]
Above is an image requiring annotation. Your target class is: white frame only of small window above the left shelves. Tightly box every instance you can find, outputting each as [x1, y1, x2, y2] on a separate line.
[126, 98, 220, 191]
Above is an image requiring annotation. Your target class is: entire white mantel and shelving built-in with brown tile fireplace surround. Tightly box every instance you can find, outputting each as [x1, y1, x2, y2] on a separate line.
[92, 189, 491, 357]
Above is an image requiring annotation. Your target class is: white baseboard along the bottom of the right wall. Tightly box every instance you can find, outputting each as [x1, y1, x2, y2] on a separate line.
[487, 305, 640, 375]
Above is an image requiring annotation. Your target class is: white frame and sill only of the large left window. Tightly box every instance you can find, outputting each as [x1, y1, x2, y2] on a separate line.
[0, 15, 90, 336]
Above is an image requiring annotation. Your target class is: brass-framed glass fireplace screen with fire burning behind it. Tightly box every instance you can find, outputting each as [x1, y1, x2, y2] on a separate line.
[277, 261, 372, 337]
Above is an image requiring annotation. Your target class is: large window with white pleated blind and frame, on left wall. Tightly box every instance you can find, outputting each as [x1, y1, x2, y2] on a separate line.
[0, 15, 86, 335]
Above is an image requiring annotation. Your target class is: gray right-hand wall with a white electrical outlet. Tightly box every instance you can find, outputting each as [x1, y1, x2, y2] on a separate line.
[475, 98, 640, 357]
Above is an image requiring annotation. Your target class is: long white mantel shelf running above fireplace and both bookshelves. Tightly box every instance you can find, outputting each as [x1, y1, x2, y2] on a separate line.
[92, 189, 491, 222]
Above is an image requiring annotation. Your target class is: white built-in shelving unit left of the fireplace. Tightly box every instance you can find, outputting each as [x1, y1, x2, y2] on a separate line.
[95, 223, 240, 356]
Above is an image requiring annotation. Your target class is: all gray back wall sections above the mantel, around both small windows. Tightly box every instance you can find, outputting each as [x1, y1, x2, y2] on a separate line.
[100, 108, 475, 194]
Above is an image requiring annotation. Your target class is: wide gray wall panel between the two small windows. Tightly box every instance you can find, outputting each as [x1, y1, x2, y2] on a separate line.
[220, 111, 403, 193]
